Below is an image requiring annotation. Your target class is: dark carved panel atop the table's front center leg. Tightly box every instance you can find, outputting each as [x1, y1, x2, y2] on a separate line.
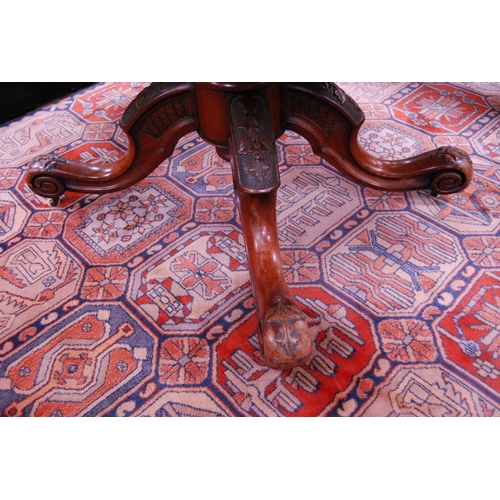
[231, 96, 279, 191]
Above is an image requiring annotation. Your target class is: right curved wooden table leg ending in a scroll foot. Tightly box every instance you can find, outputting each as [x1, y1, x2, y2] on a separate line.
[282, 83, 473, 195]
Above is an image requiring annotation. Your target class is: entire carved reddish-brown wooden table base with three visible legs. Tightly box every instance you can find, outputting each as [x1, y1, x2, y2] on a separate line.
[26, 83, 472, 369]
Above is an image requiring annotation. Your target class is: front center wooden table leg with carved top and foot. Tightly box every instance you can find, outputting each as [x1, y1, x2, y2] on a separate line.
[230, 95, 312, 369]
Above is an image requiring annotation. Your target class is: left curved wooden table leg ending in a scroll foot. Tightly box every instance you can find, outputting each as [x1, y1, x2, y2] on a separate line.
[26, 83, 197, 205]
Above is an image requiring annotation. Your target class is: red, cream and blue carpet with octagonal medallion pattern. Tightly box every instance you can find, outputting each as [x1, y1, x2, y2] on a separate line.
[0, 83, 500, 416]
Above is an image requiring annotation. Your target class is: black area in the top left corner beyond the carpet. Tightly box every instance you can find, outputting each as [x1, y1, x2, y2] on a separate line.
[0, 82, 93, 125]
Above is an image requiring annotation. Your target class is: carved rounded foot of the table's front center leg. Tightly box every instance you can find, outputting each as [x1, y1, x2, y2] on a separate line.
[259, 296, 312, 370]
